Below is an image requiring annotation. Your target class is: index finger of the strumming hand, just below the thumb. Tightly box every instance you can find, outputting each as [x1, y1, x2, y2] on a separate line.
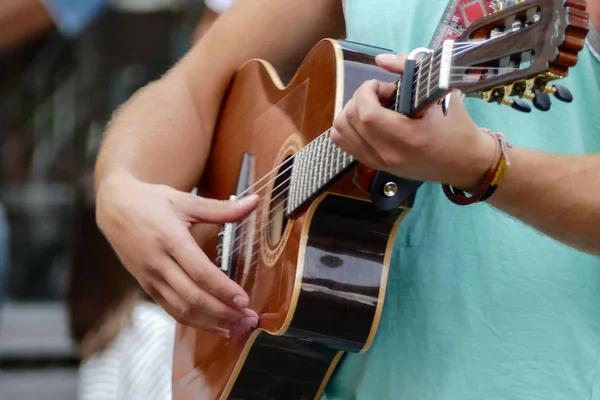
[167, 227, 258, 310]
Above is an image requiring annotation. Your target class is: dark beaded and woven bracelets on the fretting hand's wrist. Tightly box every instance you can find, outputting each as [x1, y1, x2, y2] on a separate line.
[442, 128, 511, 206]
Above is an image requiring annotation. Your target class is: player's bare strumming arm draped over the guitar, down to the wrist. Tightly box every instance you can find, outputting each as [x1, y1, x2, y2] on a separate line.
[95, 0, 344, 190]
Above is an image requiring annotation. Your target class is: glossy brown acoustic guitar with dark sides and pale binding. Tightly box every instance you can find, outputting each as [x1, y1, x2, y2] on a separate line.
[173, 0, 588, 400]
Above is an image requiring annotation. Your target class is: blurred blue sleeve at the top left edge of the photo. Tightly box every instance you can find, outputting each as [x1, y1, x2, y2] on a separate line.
[40, 0, 108, 37]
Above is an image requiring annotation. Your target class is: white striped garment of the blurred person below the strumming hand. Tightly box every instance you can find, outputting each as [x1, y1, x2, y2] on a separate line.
[78, 302, 175, 400]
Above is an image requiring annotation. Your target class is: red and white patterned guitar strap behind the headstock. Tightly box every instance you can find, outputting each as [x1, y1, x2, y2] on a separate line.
[429, 0, 517, 49]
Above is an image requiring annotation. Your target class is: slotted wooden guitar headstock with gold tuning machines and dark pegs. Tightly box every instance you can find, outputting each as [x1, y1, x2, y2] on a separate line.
[440, 0, 588, 111]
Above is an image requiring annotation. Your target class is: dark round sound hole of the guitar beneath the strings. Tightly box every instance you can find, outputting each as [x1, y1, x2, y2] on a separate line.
[267, 156, 292, 247]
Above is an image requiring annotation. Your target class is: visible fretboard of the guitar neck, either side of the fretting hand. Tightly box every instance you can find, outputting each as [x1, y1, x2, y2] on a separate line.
[287, 48, 450, 215]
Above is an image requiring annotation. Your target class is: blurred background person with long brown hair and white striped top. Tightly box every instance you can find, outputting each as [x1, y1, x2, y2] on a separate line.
[67, 0, 212, 400]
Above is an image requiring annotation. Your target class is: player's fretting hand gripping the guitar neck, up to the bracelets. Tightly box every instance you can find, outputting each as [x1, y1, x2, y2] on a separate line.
[331, 54, 496, 189]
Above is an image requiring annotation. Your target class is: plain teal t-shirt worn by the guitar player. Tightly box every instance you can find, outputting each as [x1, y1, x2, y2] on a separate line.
[325, 0, 600, 400]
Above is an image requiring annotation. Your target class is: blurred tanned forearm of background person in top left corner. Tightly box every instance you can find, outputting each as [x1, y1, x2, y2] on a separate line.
[0, 0, 54, 54]
